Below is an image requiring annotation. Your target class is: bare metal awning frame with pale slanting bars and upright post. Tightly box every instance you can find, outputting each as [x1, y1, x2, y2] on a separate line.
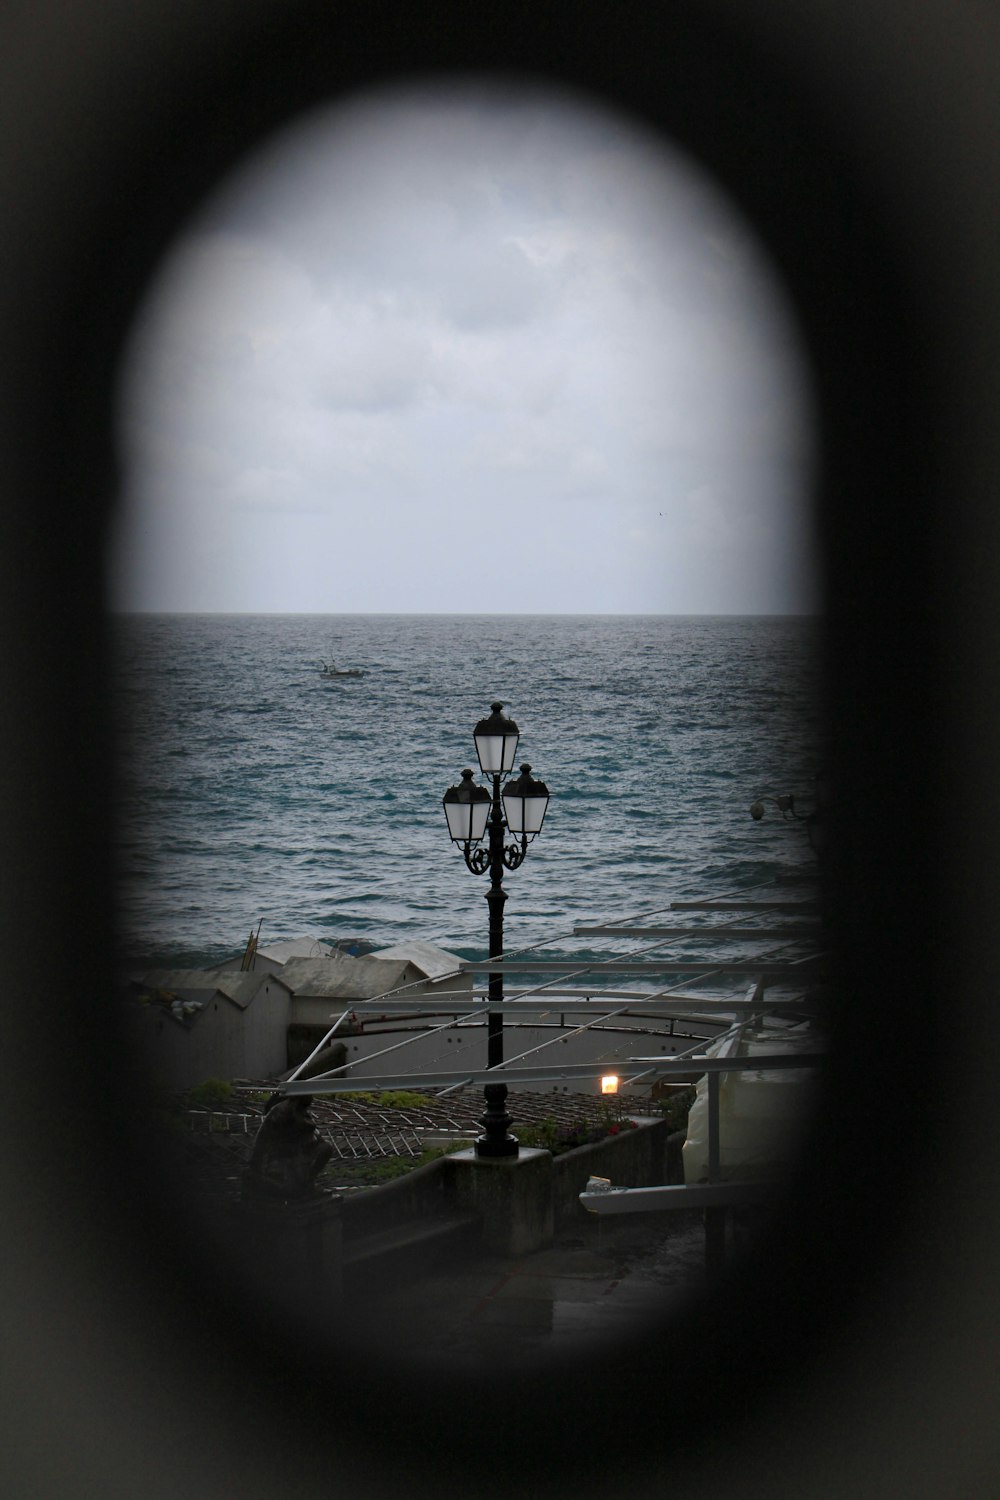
[275, 876, 825, 1278]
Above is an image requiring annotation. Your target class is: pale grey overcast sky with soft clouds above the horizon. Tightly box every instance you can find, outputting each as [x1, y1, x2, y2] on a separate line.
[112, 84, 816, 614]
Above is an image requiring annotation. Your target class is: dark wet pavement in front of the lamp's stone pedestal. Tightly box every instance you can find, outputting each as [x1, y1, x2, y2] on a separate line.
[350, 1212, 705, 1371]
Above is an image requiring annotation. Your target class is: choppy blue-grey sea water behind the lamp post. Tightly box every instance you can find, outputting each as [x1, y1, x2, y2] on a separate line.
[114, 615, 823, 965]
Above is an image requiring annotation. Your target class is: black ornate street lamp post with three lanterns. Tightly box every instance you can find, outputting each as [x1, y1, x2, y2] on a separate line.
[444, 702, 549, 1157]
